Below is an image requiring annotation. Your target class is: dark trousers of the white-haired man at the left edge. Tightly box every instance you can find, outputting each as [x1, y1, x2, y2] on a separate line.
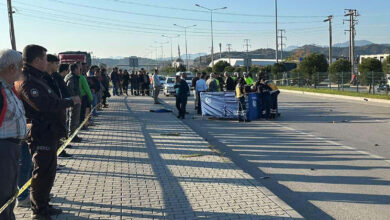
[0, 139, 21, 220]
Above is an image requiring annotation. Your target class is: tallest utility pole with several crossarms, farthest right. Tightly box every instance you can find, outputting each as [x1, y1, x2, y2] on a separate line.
[344, 9, 359, 80]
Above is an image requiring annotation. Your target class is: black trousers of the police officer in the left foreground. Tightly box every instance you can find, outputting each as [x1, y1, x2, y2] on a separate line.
[29, 141, 58, 214]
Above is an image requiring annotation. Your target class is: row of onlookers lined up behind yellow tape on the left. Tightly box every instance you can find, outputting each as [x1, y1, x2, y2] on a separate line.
[0, 45, 110, 220]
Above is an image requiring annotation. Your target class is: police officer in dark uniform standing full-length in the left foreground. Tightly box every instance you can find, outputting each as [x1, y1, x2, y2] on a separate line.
[15, 45, 81, 220]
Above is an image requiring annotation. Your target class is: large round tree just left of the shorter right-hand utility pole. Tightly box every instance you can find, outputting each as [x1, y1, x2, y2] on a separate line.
[298, 53, 328, 87]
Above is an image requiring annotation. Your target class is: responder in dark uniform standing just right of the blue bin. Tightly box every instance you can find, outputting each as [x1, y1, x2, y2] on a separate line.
[253, 74, 272, 120]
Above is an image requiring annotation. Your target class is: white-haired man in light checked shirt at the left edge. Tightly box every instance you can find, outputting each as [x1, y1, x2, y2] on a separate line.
[0, 49, 27, 220]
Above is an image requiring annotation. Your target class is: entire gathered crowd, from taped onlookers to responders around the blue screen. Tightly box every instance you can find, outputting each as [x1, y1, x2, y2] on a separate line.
[0, 45, 279, 220]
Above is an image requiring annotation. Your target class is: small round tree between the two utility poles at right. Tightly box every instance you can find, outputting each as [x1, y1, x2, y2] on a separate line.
[329, 59, 351, 85]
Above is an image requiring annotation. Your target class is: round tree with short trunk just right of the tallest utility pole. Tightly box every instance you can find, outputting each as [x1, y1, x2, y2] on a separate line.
[358, 58, 384, 92]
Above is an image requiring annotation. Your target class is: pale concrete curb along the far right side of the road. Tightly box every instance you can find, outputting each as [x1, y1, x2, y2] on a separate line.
[280, 89, 390, 105]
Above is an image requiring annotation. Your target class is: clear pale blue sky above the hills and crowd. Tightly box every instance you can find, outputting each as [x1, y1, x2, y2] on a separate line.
[0, 0, 390, 58]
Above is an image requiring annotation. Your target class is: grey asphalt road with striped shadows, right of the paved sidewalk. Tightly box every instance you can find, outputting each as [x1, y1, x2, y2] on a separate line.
[159, 93, 390, 219]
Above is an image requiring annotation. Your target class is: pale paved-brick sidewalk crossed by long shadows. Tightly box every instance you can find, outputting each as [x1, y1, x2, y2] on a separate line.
[15, 97, 300, 219]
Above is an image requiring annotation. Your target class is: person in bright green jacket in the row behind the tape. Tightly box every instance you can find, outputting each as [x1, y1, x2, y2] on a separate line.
[79, 74, 93, 128]
